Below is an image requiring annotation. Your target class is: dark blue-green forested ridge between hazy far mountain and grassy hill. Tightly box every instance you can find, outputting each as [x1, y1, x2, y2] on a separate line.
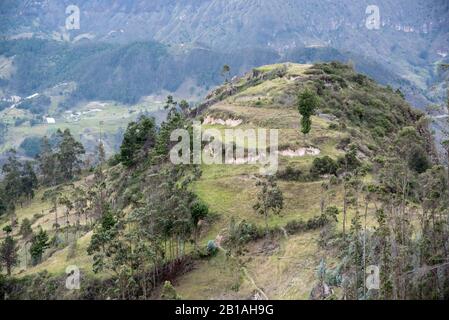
[0, 39, 434, 105]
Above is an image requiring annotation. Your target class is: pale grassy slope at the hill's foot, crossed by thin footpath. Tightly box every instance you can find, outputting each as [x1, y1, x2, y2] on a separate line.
[174, 232, 328, 300]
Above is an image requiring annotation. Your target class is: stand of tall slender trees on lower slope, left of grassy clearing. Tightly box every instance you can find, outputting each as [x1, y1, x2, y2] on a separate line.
[88, 166, 209, 299]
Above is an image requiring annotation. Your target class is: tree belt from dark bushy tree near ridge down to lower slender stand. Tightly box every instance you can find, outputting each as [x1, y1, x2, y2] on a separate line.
[88, 107, 209, 299]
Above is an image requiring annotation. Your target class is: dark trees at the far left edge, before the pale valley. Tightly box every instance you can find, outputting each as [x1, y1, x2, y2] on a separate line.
[0, 129, 84, 275]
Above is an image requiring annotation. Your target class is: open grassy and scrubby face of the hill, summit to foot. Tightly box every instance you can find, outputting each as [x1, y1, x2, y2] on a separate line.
[171, 64, 433, 299]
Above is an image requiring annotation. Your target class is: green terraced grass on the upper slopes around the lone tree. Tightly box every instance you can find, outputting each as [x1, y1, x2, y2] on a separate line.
[194, 72, 347, 237]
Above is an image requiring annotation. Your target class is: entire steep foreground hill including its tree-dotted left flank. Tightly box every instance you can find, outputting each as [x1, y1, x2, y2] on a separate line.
[2, 63, 437, 299]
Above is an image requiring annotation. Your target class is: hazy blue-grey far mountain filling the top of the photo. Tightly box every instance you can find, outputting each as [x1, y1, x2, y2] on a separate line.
[0, 0, 449, 105]
